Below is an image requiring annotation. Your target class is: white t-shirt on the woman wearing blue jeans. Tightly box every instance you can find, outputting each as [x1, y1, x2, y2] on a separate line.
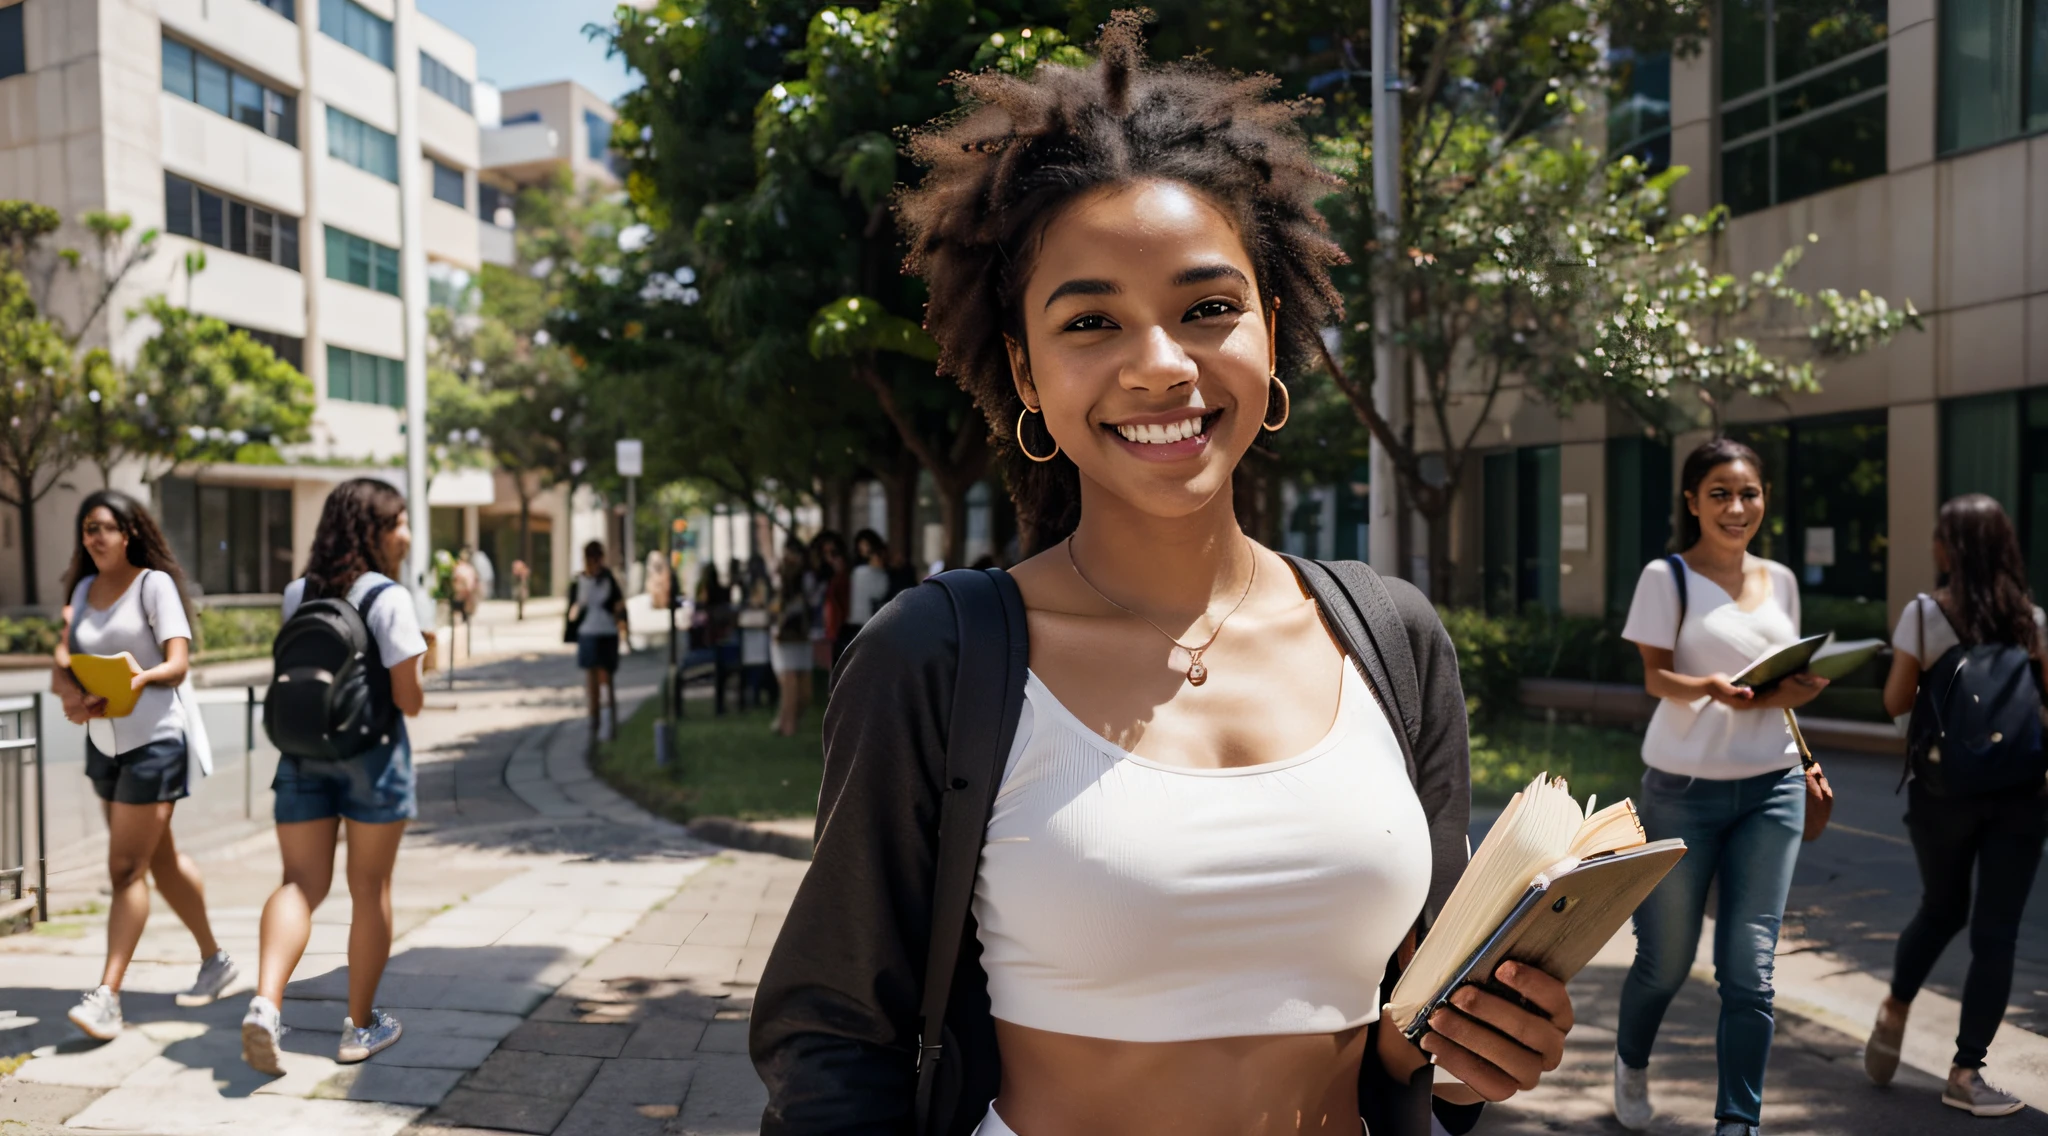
[1622, 557, 1798, 782]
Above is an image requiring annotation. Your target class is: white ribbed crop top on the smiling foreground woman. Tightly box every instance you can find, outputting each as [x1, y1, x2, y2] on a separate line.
[975, 665, 1432, 1042]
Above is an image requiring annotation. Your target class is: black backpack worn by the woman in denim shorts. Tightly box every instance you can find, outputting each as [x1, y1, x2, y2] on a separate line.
[262, 579, 397, 761]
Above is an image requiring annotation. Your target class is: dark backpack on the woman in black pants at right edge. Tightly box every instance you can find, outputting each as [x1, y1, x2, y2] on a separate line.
[1907, 596, 2048, 796]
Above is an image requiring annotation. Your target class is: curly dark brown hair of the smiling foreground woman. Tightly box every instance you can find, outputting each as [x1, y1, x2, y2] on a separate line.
[897, 10, 1346, 551]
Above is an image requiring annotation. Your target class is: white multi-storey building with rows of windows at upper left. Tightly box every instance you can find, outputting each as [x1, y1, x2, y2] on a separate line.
[0, 0, 598, 606]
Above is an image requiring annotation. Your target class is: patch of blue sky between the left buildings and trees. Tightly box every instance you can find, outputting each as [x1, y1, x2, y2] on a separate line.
[420, 0, 639, 100]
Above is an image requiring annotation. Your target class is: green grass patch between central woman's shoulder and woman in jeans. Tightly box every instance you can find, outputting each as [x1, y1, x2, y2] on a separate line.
[1473, 716, 1642, 804]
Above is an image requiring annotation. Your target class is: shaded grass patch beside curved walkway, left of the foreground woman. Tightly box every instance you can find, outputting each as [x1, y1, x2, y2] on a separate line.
[592, 698, 825, 821]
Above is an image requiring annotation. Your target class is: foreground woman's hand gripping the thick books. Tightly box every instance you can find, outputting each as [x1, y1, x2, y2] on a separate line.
[1421, 962, 1573, 1101]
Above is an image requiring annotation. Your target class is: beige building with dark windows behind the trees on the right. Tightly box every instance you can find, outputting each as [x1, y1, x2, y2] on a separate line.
[1400, 0, 2048, 659]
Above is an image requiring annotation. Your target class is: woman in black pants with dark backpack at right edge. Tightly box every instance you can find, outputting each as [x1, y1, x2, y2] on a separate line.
[1864, 493, 2048, 1116]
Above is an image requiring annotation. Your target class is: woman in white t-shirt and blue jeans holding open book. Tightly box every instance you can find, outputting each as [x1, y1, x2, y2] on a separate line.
[1614, 438, 1827, 1136]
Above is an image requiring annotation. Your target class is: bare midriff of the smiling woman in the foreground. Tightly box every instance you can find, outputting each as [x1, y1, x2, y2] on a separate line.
[995, 1019, 1376, 1136]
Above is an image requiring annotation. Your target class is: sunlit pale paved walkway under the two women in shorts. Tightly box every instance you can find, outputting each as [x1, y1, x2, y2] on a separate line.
[0, 638, 737, 1136]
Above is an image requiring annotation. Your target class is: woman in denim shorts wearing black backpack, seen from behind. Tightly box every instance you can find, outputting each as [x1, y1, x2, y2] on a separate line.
[242, 477, 426, 1077]
